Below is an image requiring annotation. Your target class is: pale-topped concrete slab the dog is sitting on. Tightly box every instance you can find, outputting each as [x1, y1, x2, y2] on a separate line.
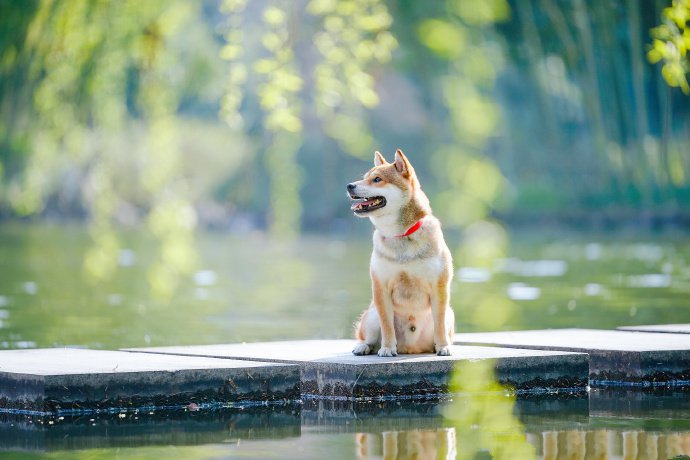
[123, 340, 588, 399]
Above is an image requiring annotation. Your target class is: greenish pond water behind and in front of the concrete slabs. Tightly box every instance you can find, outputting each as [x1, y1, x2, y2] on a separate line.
[0, 224, 690, 459]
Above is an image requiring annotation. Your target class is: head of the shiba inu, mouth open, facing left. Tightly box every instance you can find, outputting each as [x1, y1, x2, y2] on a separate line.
[347, 149, 419, 217]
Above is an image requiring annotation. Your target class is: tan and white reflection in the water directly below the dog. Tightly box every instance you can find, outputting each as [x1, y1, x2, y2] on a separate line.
[355, 428, 457, 459]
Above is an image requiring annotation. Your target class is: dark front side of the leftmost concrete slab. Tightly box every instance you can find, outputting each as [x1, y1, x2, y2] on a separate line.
[0, 365, 301, 415]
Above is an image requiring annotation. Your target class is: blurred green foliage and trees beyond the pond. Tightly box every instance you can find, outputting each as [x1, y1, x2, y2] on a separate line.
[0, 0, 690, 244]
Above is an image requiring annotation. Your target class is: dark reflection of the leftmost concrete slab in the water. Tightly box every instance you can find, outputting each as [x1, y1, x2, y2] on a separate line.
[0, 404, 301, 452]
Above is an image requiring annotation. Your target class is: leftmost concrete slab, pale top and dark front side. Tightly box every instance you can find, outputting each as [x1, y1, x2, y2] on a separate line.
[0, 348, 300, 414]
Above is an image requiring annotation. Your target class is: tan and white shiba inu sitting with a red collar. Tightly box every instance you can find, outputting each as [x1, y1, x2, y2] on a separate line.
[347, 150, 455, 356]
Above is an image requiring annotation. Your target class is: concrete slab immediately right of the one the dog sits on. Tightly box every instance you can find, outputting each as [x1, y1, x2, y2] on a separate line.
[455, 329, 690, 388]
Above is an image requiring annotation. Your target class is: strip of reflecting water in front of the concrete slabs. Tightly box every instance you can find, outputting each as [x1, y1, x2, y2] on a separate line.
[0, 390, 690, 460]
